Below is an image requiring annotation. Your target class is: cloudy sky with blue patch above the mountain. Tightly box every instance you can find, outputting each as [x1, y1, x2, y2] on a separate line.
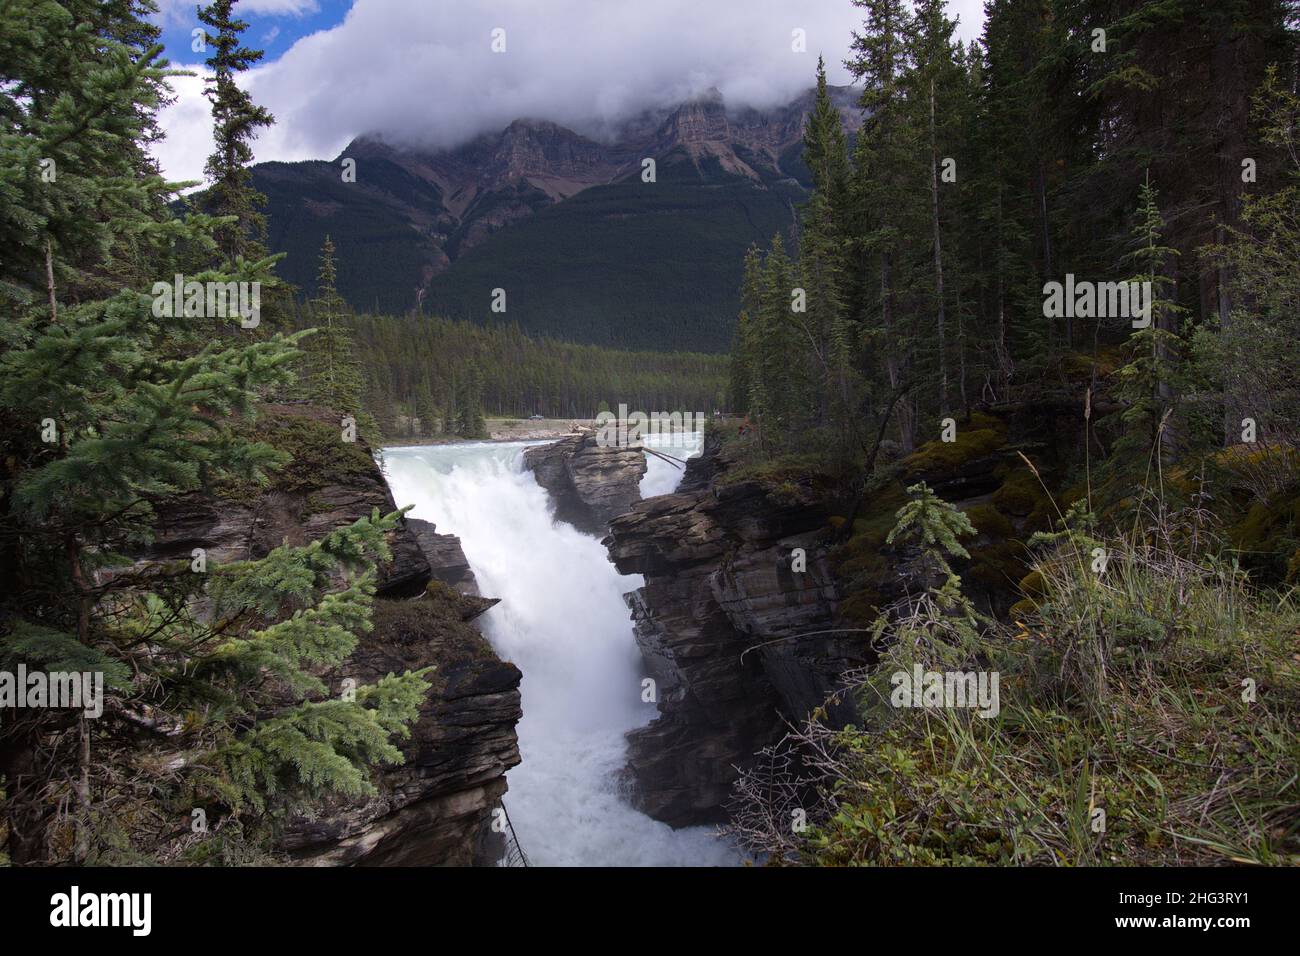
[156, 0, 983, 187]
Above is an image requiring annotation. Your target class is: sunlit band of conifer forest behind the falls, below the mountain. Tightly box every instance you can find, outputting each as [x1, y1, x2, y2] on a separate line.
[277, 237, 727, 441]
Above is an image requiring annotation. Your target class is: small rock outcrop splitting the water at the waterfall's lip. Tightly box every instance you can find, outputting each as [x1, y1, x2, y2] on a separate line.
[524, 432, 646, 535]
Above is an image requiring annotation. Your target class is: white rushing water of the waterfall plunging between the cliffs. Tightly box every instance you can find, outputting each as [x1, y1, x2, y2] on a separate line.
[384, 438, 738, 866]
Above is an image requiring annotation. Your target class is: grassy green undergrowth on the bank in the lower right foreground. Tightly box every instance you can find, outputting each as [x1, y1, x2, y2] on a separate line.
[733, 485, 1300, 865]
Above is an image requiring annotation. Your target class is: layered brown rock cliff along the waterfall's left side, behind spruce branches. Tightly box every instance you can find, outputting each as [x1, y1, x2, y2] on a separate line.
[130, 406, 521, 865]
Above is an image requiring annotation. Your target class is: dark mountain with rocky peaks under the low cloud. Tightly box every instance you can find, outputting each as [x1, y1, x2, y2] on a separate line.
[254, 87, 859, 351]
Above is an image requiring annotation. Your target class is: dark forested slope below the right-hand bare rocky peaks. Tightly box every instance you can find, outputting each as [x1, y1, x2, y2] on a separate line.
[425, 158, 805, 352]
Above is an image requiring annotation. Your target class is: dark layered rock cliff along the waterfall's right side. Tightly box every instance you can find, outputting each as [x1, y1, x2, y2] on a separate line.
[605, 440, 867, 826]
